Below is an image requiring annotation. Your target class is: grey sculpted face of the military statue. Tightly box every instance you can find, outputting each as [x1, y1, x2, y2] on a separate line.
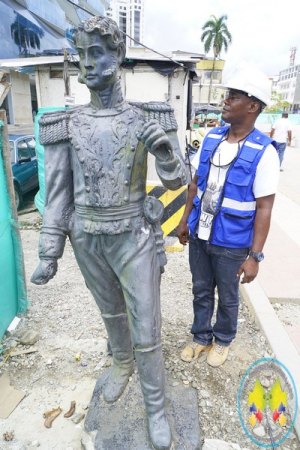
[76, 32, 120, 91]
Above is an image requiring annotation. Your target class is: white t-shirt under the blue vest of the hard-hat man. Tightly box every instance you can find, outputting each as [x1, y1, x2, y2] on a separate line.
[192, 141, 279, 240]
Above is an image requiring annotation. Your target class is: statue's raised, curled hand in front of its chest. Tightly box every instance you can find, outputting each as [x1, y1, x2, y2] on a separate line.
[138, 119, 173, 161]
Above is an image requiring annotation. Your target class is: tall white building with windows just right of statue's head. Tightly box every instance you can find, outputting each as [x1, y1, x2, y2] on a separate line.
[106, 0, 145, 48]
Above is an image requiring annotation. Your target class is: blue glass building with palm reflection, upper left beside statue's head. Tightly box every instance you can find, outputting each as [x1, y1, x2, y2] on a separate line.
[0, 0, 109, 59]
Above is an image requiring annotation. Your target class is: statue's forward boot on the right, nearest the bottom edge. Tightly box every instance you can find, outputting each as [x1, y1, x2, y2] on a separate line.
[135, 346, 172, 450]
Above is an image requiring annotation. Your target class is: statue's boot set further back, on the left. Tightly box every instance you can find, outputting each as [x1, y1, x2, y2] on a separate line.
[102, 313, 133, 403]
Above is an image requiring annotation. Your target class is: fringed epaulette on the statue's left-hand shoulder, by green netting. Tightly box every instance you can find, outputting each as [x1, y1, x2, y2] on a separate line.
[39, 111, 69, 145]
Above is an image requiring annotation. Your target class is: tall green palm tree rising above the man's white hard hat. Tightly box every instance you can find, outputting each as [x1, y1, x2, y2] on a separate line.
[201, 15, 231, 104]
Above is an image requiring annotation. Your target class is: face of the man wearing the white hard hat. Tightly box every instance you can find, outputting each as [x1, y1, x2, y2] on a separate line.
[222, 89, 251, 124]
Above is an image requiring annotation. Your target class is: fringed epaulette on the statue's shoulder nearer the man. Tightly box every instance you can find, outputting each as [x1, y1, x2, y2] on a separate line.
[129, 102, 178, 133]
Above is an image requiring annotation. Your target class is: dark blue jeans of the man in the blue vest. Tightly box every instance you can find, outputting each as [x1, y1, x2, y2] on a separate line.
[189, 236, 249, 347]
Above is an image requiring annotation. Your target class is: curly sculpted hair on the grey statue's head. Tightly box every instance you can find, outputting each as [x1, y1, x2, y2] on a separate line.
[73, 16, 125, 55]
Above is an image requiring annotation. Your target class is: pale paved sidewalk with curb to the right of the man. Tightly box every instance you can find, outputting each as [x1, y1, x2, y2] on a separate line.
[241, 135, 300, 437]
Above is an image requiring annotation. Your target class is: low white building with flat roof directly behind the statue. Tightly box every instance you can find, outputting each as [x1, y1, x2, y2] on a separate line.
[0, 48, 197, 148]
